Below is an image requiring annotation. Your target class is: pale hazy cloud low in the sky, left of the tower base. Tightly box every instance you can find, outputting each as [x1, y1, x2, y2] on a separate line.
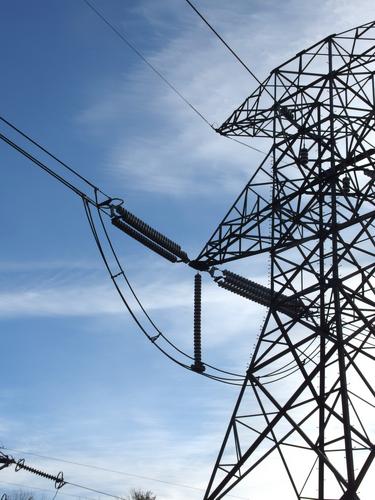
[2, 384, 247, 500]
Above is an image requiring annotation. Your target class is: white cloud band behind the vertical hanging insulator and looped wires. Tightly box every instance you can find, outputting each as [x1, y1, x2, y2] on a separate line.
[0, 260, 265, 371]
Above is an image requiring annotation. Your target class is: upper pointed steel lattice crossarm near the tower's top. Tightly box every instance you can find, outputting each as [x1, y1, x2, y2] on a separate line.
[217, 22, 375, 139]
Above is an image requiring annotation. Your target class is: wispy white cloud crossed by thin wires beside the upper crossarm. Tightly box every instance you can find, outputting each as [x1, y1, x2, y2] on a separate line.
[77, 0, 374, 198]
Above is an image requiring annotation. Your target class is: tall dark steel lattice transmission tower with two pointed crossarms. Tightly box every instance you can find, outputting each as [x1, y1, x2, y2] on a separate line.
[195, 22, 375, 500]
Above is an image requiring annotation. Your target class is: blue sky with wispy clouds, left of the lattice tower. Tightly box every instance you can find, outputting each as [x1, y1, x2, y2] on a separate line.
[0, 0, 375, 500]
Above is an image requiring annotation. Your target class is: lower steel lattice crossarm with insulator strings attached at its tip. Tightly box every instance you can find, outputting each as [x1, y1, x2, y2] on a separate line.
[190, 148, 375, 269]
